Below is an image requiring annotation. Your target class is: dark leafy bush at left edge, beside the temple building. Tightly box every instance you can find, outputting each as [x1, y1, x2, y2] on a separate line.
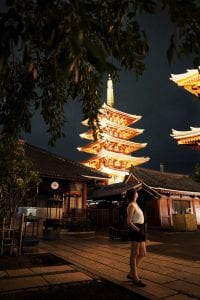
[0, 139, 39, 219]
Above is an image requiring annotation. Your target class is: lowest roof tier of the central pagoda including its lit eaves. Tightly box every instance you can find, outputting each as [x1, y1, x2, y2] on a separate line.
[82, 149, 150, 171]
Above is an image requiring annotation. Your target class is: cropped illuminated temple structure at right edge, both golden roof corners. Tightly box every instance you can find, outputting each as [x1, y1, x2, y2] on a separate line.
[170, 67, 200, 150]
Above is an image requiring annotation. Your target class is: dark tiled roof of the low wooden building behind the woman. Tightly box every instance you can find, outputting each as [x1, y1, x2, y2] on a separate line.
[90, 167, 200, 199]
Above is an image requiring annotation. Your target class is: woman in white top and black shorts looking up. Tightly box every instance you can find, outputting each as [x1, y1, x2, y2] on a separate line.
[126, 189, 146, 287]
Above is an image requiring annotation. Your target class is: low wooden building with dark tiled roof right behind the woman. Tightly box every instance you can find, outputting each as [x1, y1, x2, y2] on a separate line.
[90, 167, 200, 231]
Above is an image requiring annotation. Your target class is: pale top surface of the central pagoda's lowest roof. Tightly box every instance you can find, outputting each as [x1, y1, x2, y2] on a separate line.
[82, 149, 150, 167]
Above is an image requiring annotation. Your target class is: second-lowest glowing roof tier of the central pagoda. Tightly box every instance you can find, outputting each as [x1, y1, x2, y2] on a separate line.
[78, 133, 147, 154]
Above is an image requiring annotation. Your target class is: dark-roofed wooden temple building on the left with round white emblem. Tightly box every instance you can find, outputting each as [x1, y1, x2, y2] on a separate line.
[24, 143, 108, 219]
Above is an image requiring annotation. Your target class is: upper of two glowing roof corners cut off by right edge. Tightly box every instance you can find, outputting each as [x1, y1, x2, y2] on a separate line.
[170, 68, 200, 96]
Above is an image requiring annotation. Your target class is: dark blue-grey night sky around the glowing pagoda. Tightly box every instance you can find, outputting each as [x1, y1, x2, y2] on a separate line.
[26, 8, 200, 174]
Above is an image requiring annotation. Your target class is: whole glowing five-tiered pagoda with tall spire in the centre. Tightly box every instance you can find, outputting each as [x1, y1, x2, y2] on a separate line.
[78, 76, 149, 184]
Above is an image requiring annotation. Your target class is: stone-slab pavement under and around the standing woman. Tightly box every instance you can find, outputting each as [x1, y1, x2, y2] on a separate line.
[0, 231, 200, 300]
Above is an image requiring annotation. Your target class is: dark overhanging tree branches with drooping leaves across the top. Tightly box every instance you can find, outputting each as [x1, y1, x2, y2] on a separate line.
[0, 0, 200, 144]
